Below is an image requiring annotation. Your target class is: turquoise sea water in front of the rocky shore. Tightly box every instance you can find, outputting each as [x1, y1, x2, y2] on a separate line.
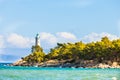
[0, 63, 120, 80]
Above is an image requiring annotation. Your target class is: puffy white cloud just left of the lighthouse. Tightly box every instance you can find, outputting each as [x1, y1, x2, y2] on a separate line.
[7, 33, 33, 48]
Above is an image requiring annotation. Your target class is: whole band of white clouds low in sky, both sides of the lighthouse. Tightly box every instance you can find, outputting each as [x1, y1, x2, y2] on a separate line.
[0, 32, 119, 49]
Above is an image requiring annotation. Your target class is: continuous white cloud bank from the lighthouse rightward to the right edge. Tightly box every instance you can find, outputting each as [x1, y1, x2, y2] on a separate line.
[40, 32, 119, 49]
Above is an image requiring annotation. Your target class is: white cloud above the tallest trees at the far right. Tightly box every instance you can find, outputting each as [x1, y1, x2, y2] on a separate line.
[81, 32, 119, 42]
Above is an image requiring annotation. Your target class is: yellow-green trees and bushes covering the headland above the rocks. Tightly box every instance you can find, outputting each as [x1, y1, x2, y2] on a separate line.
[23, 37, 120, 63]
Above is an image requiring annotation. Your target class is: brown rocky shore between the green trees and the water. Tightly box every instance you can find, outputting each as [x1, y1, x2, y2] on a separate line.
[13, 60, 120, 68]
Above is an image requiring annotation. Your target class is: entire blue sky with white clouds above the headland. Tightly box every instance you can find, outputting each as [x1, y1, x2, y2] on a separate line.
[0, 0, 120, 62]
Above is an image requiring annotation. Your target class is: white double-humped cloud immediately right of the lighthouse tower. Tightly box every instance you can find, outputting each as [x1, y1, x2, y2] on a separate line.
[40, 32, 76, 49]
